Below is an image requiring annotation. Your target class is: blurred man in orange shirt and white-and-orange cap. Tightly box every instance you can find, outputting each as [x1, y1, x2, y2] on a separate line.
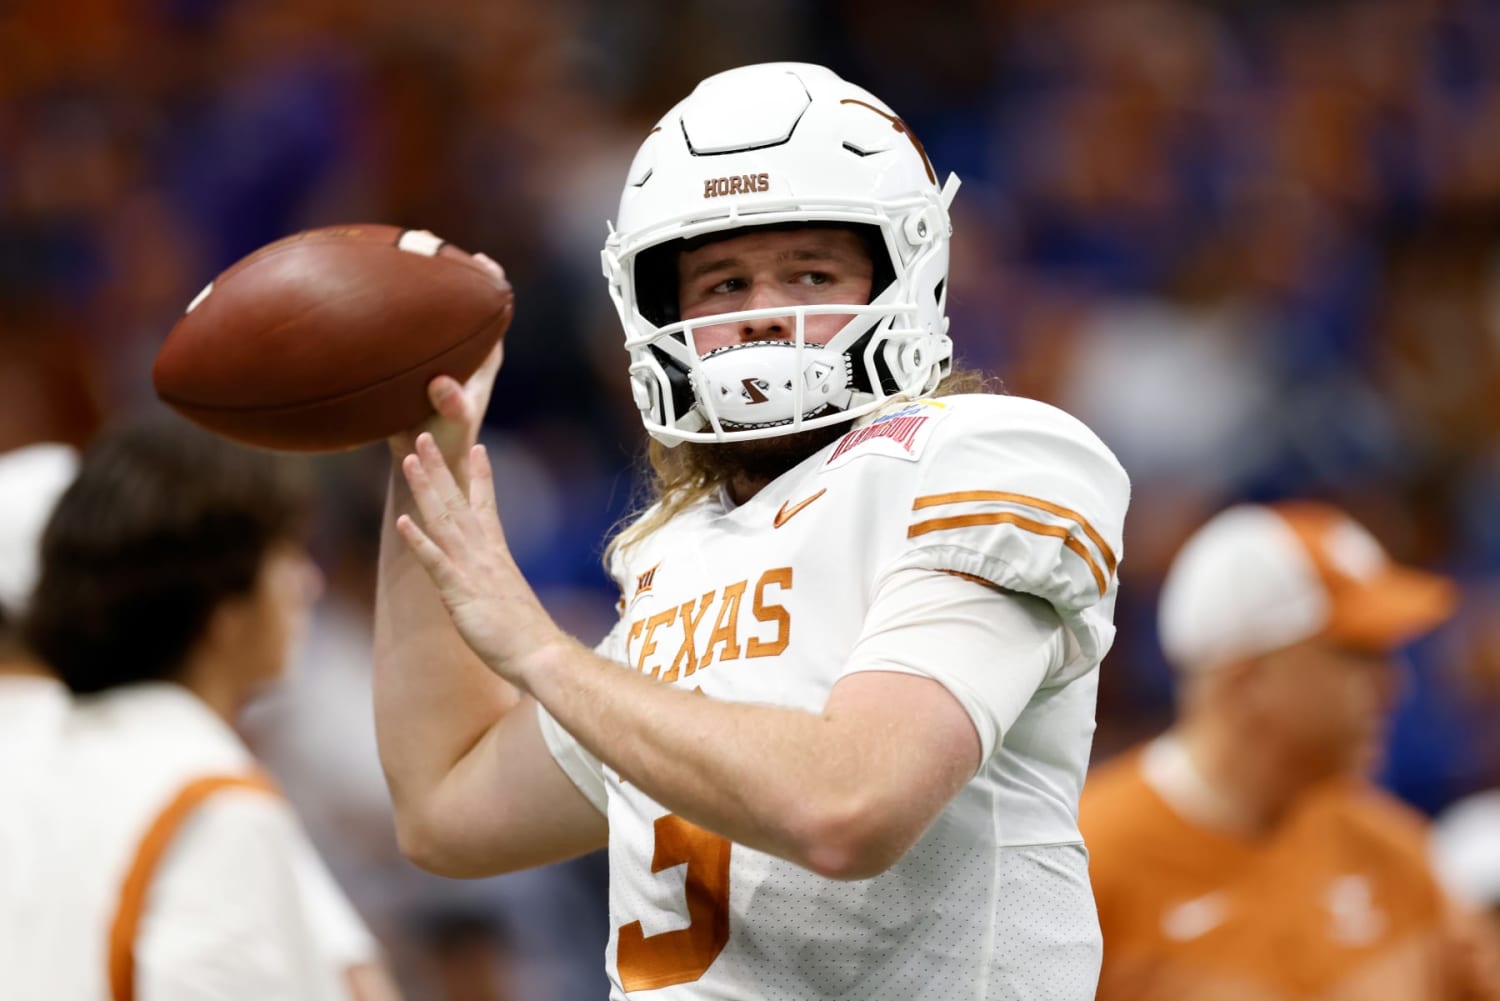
[1080, 503, 1500, 1001]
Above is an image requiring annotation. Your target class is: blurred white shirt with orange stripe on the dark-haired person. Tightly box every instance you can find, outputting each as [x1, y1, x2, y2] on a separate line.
[0, 683, 377, 1001]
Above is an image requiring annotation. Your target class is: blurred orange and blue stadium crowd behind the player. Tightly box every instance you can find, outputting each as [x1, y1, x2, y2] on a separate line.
[0, 0, 1500, 1001]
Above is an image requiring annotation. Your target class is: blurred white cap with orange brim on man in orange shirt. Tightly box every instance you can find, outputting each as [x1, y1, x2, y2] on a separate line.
[1158, 501, 1458, 671]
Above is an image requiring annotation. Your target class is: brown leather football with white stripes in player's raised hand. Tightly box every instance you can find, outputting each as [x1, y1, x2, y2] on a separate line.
[152, 225, 515, 452]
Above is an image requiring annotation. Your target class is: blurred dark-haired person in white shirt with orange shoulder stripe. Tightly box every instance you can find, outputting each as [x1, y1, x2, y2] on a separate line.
[0, 422, 395, 1001]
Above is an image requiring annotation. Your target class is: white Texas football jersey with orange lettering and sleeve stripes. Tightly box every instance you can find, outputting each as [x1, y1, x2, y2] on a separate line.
[542, 396, 1130, 1001]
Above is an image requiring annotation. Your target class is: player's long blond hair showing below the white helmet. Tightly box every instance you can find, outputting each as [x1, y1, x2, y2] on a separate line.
[605, 368, 1004, 570]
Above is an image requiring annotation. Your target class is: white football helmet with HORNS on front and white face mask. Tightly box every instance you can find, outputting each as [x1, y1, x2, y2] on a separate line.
[603, 63, 959, 446]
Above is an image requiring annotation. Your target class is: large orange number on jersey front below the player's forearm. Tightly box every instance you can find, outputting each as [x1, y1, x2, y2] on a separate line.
[615, 813, 731, 993]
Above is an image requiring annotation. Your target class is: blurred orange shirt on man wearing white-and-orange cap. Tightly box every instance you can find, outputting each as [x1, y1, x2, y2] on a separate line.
[1079, 750, 1500, 1001]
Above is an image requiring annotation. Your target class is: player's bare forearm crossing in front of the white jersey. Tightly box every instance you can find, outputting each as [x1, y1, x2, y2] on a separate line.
[527, 644, 923, 878]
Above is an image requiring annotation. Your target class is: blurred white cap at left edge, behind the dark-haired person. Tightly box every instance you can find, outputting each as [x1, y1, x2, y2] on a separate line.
[0, 444, 78, 614]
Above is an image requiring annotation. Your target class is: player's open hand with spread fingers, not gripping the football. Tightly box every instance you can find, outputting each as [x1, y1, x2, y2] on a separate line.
[396, 432, 570, 687]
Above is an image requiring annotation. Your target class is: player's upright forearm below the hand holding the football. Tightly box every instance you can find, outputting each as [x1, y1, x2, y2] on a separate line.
[375, 474, 519, 825]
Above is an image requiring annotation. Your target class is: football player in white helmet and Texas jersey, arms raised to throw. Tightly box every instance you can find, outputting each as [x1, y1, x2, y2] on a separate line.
[377, 63, 1128, 1001]
